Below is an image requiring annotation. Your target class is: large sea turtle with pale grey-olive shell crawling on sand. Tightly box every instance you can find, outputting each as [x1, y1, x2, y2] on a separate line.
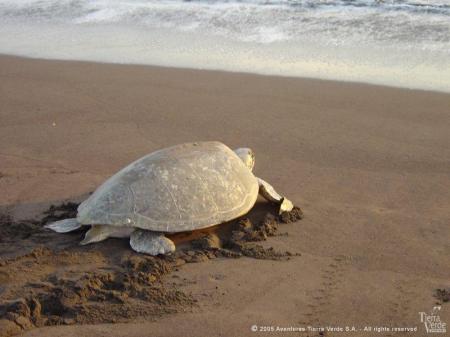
[45, 141, 293, 255]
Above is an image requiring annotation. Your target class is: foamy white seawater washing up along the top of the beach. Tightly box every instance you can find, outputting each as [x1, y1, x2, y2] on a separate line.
[0, 0, 450, 92]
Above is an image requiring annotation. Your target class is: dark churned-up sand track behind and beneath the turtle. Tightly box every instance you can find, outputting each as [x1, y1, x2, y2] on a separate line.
[0, 203, 302, 337]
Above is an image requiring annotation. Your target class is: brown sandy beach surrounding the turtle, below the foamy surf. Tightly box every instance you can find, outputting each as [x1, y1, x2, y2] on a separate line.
[0, 56, 450, 337]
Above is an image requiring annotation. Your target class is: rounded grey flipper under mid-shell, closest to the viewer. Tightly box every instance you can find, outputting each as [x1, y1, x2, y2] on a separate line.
[130, 229, 175, 256]
